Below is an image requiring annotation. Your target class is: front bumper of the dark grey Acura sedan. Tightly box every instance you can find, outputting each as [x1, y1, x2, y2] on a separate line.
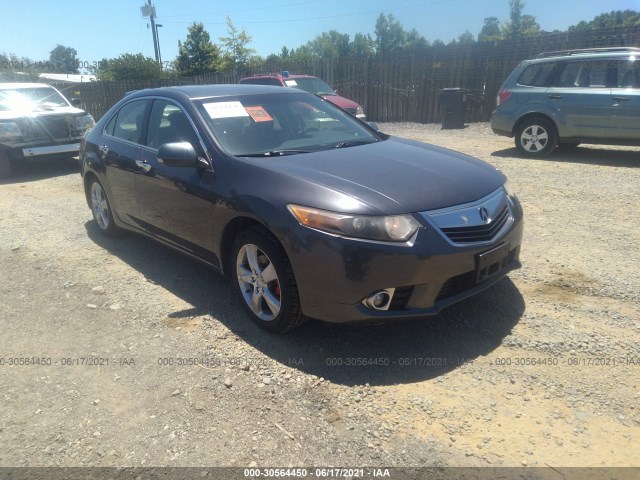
[285, 195, 523, 323]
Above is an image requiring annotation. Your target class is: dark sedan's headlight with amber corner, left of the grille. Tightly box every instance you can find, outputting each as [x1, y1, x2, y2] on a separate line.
[288, 205, 420, 242]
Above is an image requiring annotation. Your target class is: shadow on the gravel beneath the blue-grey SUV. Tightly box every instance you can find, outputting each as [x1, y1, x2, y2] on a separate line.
[491, 146, 640, 168]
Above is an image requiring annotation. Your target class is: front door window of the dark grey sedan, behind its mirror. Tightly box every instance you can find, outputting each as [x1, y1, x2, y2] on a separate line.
[145, 100, 199, 149]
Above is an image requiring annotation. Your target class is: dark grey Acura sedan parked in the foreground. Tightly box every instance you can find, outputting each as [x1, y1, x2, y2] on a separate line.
[80, 85, 523, 332]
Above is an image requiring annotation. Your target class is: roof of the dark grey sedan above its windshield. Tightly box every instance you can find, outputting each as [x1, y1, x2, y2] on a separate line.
[127, 84, 305, 99]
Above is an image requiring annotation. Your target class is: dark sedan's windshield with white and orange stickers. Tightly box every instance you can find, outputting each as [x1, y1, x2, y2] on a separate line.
[197, 93, 383, 157]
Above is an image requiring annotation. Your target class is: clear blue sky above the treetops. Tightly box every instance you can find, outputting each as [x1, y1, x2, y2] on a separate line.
[0, 0, 640, 71]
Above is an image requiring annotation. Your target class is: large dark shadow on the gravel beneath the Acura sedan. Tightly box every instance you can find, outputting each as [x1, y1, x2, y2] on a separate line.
[86, 222, 525, 385]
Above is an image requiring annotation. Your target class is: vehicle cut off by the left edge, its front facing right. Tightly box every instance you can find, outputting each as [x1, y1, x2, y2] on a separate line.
[0, 83, 95, 177]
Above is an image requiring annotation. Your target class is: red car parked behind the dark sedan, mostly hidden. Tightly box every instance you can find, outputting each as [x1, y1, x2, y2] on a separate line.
[238, 72, 367, 122]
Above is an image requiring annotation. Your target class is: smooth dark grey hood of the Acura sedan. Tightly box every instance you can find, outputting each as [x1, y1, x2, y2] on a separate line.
[263, 137, 505, 215]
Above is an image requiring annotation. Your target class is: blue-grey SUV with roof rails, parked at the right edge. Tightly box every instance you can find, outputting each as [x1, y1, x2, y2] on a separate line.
[491, 47, 640, 157]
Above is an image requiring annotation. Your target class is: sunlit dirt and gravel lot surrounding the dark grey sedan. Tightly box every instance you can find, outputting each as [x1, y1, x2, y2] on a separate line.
[0, 124, 640, 478]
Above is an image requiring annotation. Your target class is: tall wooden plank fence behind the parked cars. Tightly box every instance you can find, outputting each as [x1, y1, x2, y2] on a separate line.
[8, 27, 640, 123]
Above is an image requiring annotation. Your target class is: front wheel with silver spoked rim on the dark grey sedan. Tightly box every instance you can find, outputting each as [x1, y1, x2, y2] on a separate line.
[230, 227, 306, 333]
